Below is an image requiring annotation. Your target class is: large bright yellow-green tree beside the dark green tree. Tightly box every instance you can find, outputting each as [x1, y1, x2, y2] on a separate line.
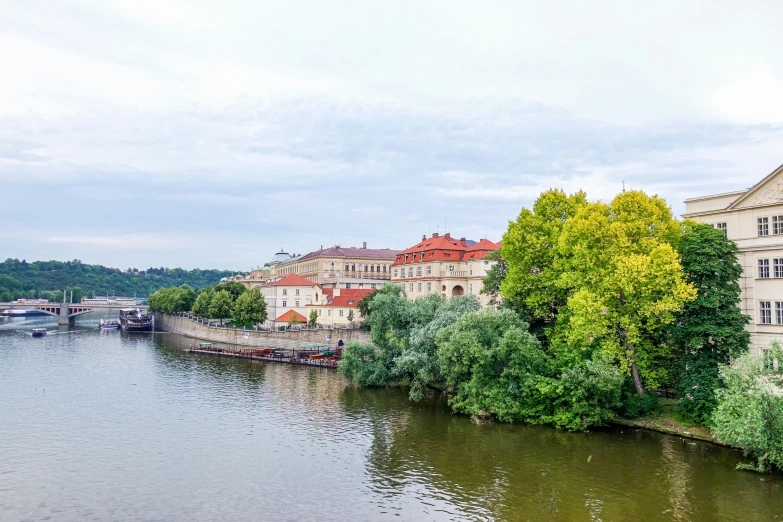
[556, 191, 696, 396]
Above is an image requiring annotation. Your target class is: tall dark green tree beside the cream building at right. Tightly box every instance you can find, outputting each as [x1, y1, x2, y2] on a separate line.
[668, 223, 750, 424]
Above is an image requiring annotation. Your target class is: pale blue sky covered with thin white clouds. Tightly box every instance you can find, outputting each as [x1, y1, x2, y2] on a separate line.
[0, 0, 783, 271]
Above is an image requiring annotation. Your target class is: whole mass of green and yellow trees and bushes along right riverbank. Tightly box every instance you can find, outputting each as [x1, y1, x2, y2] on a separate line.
[340, 190, 781, 470]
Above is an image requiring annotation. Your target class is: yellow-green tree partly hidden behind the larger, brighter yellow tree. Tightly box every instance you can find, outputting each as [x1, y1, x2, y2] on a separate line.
[502, 189, 587, 341]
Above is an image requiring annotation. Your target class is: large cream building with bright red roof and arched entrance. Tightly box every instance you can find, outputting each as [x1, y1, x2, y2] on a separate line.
[392, 233, 500, 305]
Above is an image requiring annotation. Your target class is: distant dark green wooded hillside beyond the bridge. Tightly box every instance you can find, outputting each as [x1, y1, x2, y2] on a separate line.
[0, 259, 232, 301]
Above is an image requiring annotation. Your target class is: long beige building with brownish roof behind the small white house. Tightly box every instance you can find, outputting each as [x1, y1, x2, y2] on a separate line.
[238, 242, 399, 290]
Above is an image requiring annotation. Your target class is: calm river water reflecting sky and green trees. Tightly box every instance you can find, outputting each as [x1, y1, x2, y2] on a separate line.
[0, 312, 783, 522]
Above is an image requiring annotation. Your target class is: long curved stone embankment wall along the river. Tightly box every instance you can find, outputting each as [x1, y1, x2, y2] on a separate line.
[155, 313, 370, 348]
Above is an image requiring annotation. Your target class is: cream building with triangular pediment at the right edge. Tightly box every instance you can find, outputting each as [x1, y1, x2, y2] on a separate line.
[683, 165, 783, 351]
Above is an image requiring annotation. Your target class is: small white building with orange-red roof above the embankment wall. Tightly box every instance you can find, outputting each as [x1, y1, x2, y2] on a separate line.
[258, 274, 322, 327]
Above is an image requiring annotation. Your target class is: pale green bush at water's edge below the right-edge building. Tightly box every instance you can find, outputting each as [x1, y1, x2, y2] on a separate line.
[712, 343, 783, 472]
